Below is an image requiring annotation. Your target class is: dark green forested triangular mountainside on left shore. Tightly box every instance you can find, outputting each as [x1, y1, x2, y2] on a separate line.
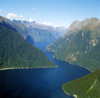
[0, 17, 56, 69]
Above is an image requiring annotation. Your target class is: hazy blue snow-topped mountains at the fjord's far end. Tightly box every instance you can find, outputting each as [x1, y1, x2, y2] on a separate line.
[12, 20, 66, 42]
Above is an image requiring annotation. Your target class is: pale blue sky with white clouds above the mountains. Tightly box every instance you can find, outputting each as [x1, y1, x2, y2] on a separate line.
[0, 0, 100, 27]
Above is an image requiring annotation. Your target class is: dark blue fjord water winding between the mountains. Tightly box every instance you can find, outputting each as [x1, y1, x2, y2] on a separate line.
[0, 43, 90, 98]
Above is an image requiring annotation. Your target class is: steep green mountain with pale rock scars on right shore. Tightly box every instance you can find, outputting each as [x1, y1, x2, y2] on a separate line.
[54, 18, 100, 71]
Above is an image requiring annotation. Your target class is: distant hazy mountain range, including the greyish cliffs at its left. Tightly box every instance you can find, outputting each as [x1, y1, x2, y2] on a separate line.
[6, 18, 67, 42]
